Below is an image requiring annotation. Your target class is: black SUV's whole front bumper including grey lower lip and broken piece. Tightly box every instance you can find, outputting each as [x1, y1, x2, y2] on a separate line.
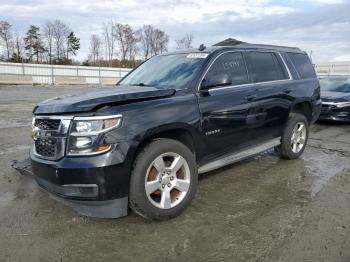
[13, 142, 130, 218]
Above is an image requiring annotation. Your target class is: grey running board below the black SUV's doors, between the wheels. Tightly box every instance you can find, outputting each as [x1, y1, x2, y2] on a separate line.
[198, 137, 281, 174]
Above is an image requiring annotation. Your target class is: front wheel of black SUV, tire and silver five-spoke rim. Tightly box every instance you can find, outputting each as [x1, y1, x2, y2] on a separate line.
[129, 138, 198, 220]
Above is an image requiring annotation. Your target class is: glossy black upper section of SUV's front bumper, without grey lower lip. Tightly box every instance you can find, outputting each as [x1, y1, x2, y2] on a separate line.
[30, 145, 130, 201]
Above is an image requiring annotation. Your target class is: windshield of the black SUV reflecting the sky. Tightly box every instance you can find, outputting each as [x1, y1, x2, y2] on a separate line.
[119, 53, 208, 89]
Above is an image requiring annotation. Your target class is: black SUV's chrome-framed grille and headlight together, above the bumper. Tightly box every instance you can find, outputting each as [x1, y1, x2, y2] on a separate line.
[32, 115, 122, 160]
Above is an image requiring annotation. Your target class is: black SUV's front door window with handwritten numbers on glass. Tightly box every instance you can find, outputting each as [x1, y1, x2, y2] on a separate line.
[205, 52, 249, 85]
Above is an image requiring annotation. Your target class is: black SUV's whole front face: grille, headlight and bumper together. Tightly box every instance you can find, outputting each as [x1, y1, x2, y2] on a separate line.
[12, 112, 133, 218]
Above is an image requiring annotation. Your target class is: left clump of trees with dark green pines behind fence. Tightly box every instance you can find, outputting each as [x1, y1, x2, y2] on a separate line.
[0, 20, 80, 64]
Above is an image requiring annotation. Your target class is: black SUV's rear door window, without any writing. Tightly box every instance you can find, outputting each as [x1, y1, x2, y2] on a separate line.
[247, 52, 288, 83]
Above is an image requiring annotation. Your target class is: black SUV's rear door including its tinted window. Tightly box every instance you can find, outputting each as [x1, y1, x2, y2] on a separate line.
[246, 51, 293, 143]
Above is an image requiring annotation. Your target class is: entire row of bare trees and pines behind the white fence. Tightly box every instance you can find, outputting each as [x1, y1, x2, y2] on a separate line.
[0, 20, 193, 67]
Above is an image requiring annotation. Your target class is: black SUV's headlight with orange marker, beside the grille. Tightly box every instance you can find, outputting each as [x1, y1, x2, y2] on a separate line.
[67, 115, 122, 155]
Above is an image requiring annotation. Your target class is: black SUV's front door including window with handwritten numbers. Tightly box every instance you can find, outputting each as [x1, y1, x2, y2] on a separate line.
[198, 52, 256, 162]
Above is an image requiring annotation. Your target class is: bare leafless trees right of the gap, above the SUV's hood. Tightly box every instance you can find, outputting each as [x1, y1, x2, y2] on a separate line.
[83, 21, 193, 67]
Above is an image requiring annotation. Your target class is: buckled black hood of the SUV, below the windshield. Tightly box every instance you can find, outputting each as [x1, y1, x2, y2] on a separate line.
[33, 86, 175, 114]
